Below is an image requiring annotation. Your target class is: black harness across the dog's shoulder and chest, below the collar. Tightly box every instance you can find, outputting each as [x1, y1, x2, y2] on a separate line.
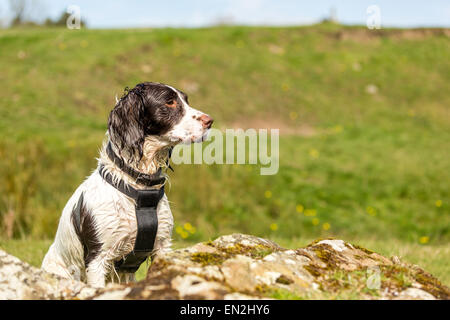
[99, 165, 164, 273]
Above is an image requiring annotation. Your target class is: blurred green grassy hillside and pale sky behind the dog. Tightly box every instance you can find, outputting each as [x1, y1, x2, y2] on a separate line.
[0, 0, 450, 284]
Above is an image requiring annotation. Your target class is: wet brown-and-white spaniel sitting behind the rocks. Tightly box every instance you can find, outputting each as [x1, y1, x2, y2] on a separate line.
[42, 82, 213, 287]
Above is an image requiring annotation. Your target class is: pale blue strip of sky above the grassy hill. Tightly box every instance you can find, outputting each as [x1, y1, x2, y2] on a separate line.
[0, 0, 450, 28]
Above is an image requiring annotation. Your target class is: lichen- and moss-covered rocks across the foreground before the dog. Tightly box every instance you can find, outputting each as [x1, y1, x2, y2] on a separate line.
[0, 234, 450, 300]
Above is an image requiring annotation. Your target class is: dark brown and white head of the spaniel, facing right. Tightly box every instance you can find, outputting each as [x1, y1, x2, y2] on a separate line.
[108, 82, 213, 161]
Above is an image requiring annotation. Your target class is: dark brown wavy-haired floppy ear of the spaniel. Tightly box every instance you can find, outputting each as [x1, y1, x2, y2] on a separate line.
[108, 90, 145, 164]
